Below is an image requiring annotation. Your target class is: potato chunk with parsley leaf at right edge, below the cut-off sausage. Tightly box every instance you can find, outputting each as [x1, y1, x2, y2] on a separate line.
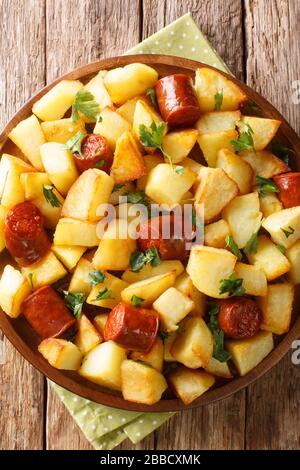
[262, 206, 300, 248]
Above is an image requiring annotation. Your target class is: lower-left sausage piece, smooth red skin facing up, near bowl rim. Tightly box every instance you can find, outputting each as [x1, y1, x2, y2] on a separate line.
[23, 286, 76, 339]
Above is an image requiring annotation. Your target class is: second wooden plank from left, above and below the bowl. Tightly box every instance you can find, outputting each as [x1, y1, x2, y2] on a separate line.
[46, 0, 144, 449]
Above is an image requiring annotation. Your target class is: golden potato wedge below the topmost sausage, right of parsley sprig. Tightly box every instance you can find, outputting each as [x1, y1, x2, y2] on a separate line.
[162, 129, 198, 163]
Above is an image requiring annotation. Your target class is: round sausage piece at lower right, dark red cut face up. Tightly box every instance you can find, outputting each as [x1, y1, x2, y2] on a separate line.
[218, 297, 262, 339]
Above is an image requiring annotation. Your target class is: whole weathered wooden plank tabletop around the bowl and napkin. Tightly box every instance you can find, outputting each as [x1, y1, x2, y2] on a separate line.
[0, 0, 300, 449]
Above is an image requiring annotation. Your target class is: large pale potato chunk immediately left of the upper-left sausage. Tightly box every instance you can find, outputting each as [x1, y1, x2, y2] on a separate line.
[40, 142, 78, 196]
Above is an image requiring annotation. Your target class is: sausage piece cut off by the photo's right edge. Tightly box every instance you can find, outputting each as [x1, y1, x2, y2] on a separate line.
[273, 172, 300, 209]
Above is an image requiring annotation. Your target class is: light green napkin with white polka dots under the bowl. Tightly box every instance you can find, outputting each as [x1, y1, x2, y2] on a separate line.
[52, 13, 230, 450]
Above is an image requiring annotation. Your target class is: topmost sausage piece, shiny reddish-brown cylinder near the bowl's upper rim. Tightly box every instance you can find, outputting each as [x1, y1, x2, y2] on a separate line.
[155, 73, 200, 127]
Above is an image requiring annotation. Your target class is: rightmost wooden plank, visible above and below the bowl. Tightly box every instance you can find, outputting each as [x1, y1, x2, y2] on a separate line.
[245, 0, 300, 449]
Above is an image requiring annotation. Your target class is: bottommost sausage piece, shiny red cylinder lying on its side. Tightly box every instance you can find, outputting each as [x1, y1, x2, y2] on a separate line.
[103, 302, 159, 352]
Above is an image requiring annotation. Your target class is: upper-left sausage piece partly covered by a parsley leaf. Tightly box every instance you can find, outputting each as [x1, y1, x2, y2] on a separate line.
[73, 134, 113, 173]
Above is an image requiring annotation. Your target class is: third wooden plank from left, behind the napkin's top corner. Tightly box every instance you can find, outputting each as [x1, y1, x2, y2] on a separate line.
[143, 0, 245, 449]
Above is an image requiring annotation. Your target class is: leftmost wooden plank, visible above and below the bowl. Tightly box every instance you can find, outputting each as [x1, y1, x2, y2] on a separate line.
[0, 0, 45, 449]
